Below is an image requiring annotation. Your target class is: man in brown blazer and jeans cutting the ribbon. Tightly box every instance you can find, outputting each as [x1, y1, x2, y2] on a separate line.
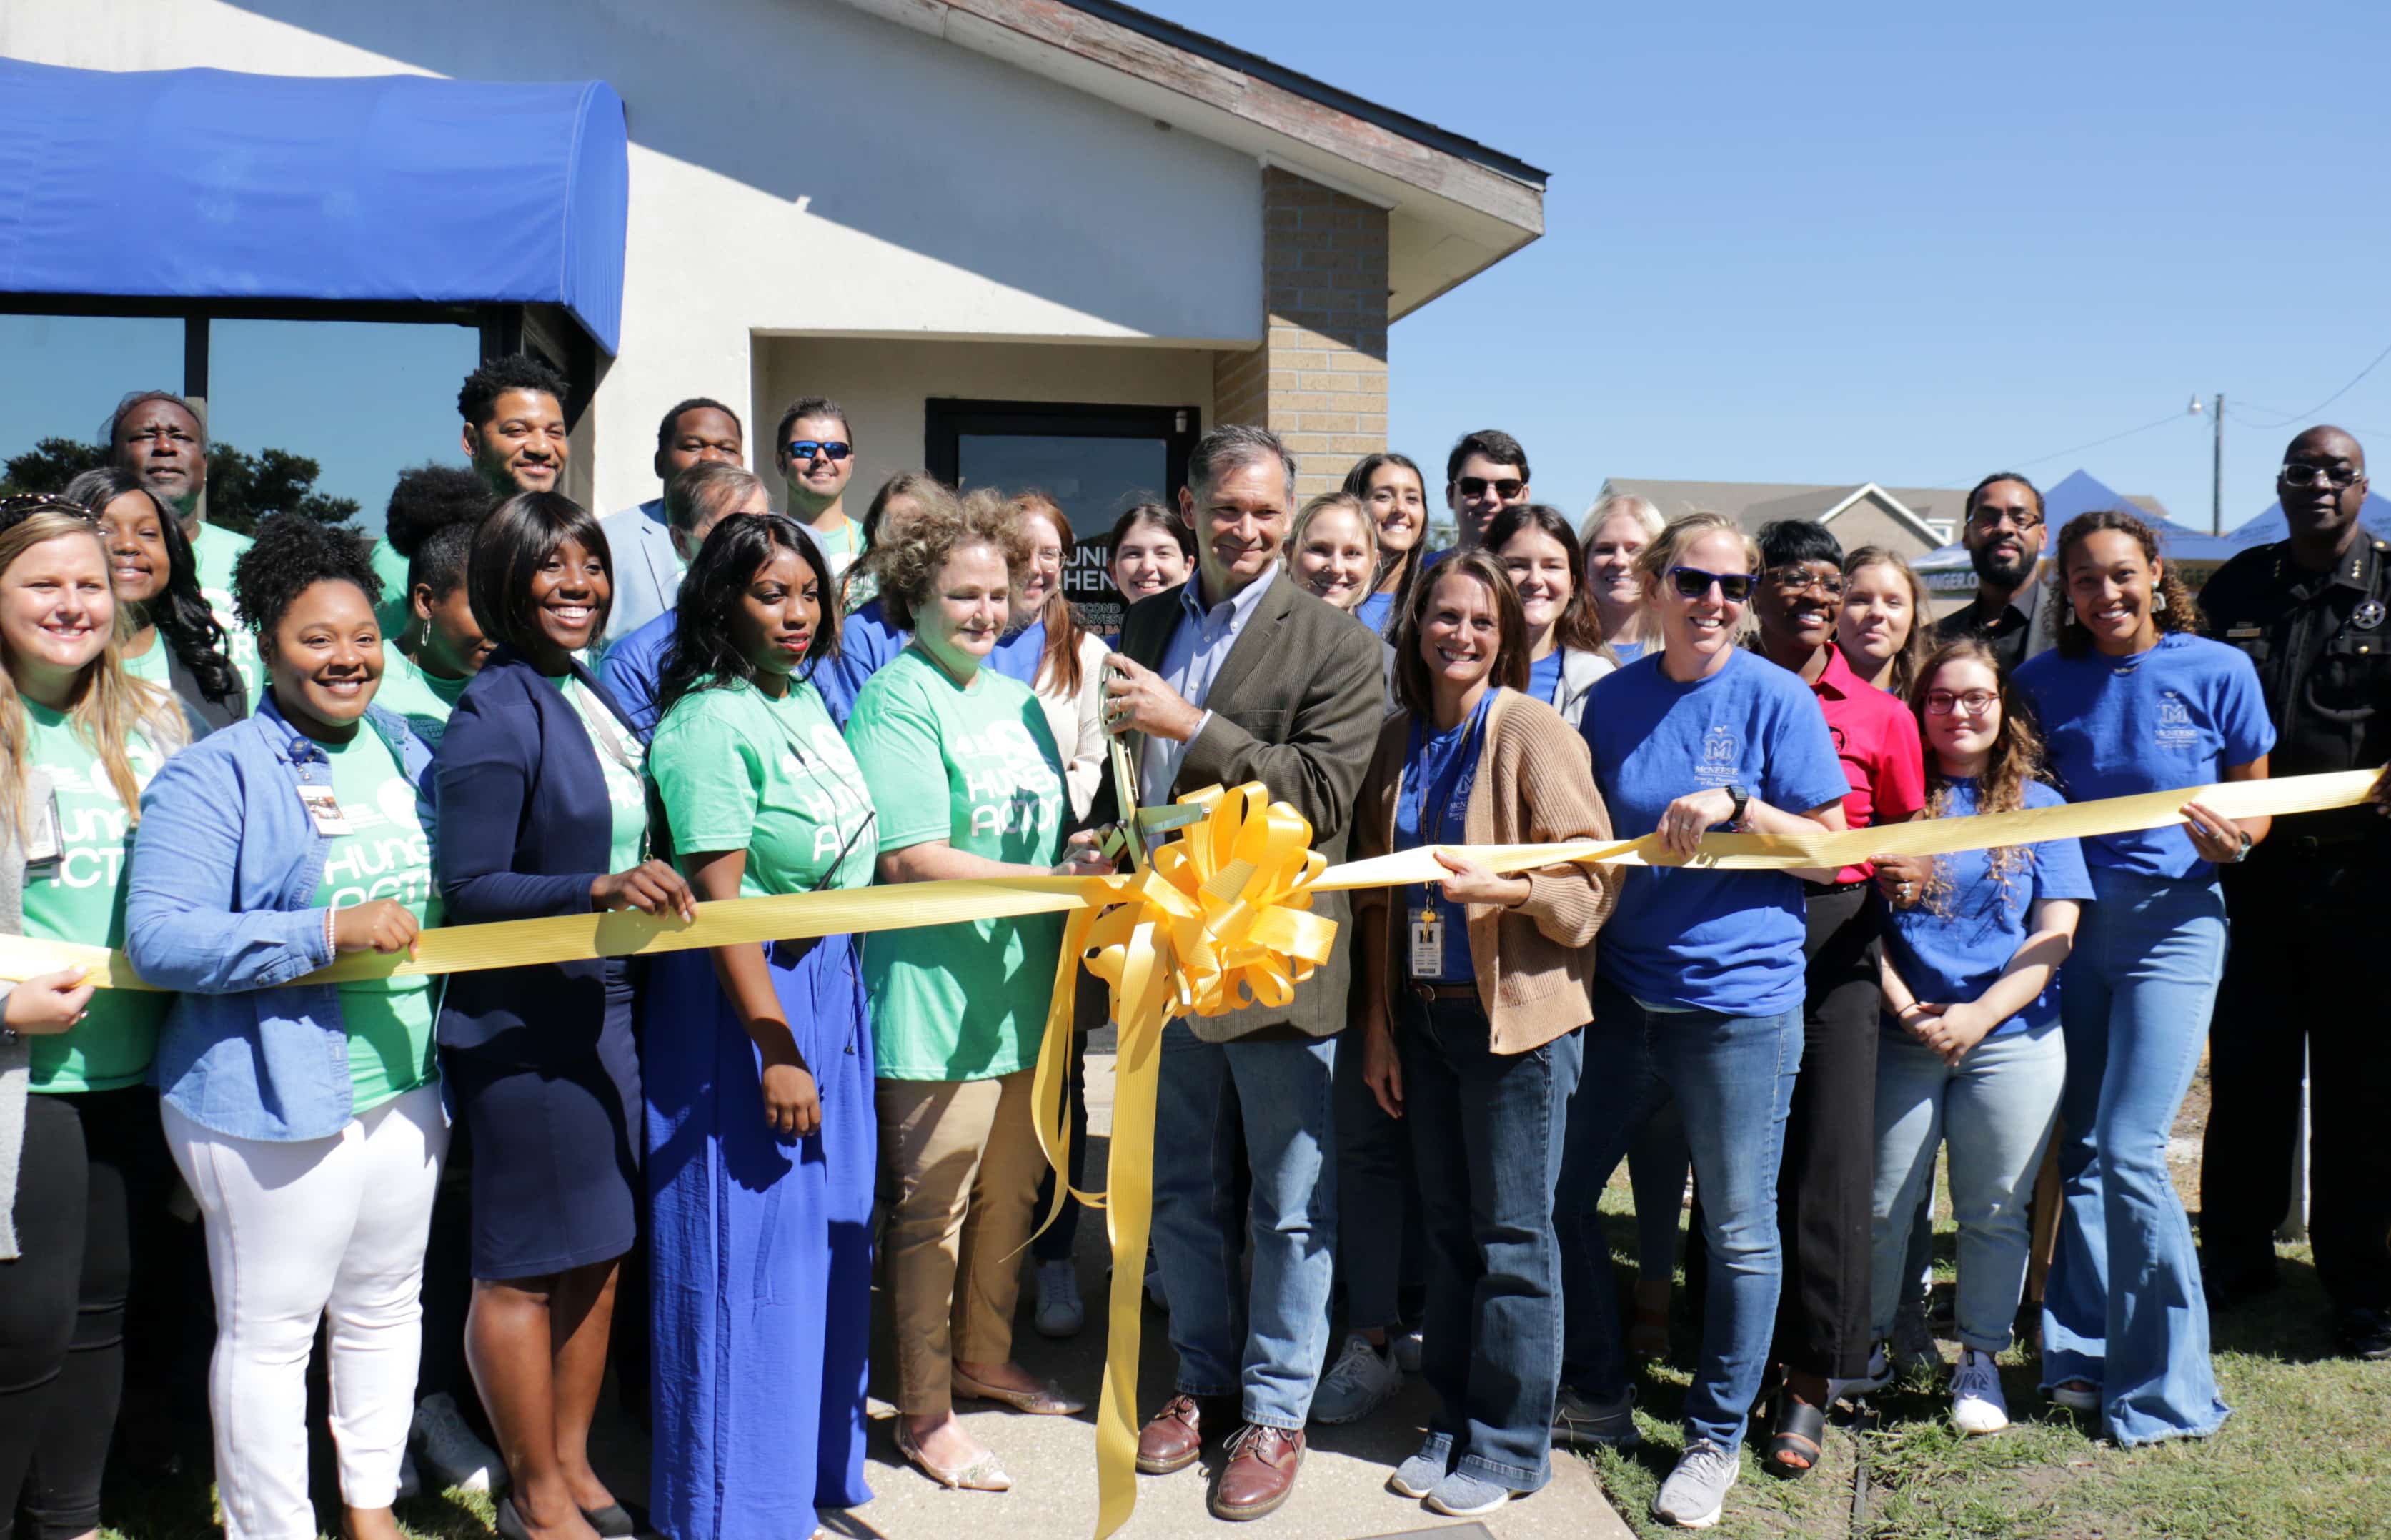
[1090, 426, 1384, 1519]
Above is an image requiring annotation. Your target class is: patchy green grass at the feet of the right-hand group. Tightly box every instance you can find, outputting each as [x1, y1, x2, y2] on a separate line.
[1597, 1157, 2391, 1540]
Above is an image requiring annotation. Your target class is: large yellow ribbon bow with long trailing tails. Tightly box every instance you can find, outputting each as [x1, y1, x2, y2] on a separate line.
[1033, 782, 1336, 1540]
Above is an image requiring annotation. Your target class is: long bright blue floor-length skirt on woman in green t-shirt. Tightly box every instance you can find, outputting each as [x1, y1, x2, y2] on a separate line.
[643, 935, 880, 1540]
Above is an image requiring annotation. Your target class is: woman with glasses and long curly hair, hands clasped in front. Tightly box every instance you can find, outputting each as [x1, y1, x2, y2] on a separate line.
[1867, 636, 2092, 1432]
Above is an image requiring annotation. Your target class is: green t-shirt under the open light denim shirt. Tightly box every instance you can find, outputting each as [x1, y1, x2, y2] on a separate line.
[316, 722, 440, 1112]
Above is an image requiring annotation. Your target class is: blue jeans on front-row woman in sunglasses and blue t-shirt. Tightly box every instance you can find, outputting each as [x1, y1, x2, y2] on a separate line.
[1554, 973, 1803, 1449]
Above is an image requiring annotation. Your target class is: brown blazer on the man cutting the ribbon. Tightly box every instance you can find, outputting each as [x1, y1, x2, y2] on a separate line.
[1080, 565, 1387, 1043]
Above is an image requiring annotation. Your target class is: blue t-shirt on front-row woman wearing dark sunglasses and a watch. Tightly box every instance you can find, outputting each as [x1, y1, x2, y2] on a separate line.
[1578, 648, 1851, 1016]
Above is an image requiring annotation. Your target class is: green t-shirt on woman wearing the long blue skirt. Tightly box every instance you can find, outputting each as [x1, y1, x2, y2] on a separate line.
[648, 679, 880, 899]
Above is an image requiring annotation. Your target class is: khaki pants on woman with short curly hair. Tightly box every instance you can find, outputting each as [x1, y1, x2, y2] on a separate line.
[878, 1069, 1045, 1416]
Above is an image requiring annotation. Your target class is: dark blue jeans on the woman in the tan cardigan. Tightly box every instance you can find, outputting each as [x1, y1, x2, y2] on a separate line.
[1370, 990, 1585, 1492]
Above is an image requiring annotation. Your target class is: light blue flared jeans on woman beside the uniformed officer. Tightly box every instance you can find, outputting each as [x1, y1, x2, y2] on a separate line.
[2042, 865, 2228, 1444]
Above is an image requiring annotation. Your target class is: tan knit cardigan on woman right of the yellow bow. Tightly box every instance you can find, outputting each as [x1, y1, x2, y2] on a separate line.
[1353, 691, 1621, 1055]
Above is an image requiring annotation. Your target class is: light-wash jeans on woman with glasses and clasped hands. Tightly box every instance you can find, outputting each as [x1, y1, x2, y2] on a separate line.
[1870, 1021, 2068, 1353]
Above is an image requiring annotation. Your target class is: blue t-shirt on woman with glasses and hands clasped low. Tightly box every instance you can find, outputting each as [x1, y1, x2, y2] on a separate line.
[1884, 780, 2092, 1038]
